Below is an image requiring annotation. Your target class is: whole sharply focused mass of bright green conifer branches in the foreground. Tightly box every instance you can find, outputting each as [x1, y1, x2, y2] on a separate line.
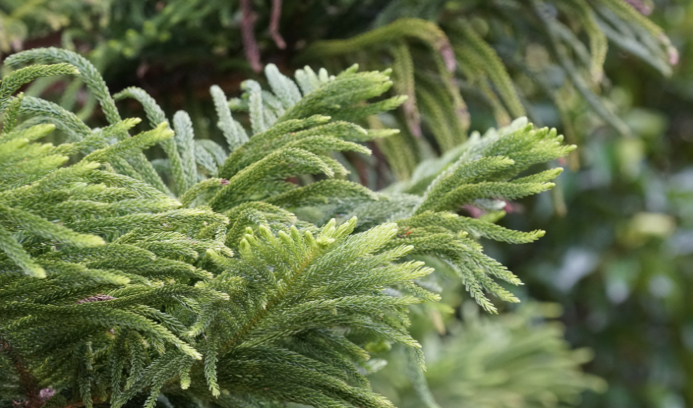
[0, 49, 570, 407]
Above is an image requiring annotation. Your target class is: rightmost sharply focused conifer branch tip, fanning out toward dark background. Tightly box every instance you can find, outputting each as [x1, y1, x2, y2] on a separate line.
[297, 119, 574, 312]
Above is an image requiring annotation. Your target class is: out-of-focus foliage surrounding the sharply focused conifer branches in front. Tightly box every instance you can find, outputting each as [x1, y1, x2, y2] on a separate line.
[0, 0, 693, 408]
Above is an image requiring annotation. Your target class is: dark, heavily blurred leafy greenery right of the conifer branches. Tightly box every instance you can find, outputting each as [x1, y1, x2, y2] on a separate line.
[498, 0, 693, 407]
